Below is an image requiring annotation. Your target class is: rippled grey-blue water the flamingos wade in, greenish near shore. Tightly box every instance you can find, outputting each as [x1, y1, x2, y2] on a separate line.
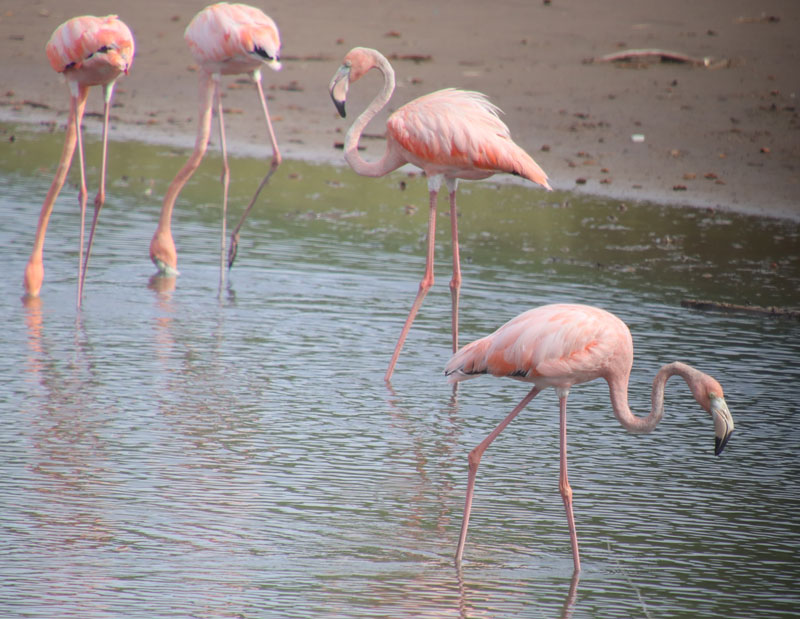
[0, 127, 800, 618]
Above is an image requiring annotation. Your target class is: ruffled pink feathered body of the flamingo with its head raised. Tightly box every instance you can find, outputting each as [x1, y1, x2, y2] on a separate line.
[387, 88, 549, 188]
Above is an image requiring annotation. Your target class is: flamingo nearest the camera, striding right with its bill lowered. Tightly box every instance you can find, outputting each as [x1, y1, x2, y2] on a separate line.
[444, 304, 733, 573]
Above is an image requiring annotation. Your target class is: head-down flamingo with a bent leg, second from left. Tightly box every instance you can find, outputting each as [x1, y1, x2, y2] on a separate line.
[150, 2, 281, 290]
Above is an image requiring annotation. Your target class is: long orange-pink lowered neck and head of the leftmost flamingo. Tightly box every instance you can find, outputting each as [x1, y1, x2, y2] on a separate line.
[23, 88, 79, 297]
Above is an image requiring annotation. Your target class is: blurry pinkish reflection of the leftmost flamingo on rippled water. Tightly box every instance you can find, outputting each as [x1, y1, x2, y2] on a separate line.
[18, 297, 124, 616]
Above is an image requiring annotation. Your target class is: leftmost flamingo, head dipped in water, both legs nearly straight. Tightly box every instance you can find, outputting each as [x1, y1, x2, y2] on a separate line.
[23, 15, 134, 307]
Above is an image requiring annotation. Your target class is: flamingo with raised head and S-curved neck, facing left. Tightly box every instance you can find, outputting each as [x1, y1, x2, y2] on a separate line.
[330, 47, 551, 381]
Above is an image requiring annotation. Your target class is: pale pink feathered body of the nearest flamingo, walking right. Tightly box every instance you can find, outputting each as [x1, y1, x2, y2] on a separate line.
[445, 304, 630, 387]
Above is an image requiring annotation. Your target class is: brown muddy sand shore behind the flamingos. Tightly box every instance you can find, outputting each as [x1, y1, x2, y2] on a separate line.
[0, 0, 800, 219]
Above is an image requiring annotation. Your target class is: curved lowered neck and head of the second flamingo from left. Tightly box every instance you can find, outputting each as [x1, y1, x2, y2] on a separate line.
[150, 72, 215, 275]
